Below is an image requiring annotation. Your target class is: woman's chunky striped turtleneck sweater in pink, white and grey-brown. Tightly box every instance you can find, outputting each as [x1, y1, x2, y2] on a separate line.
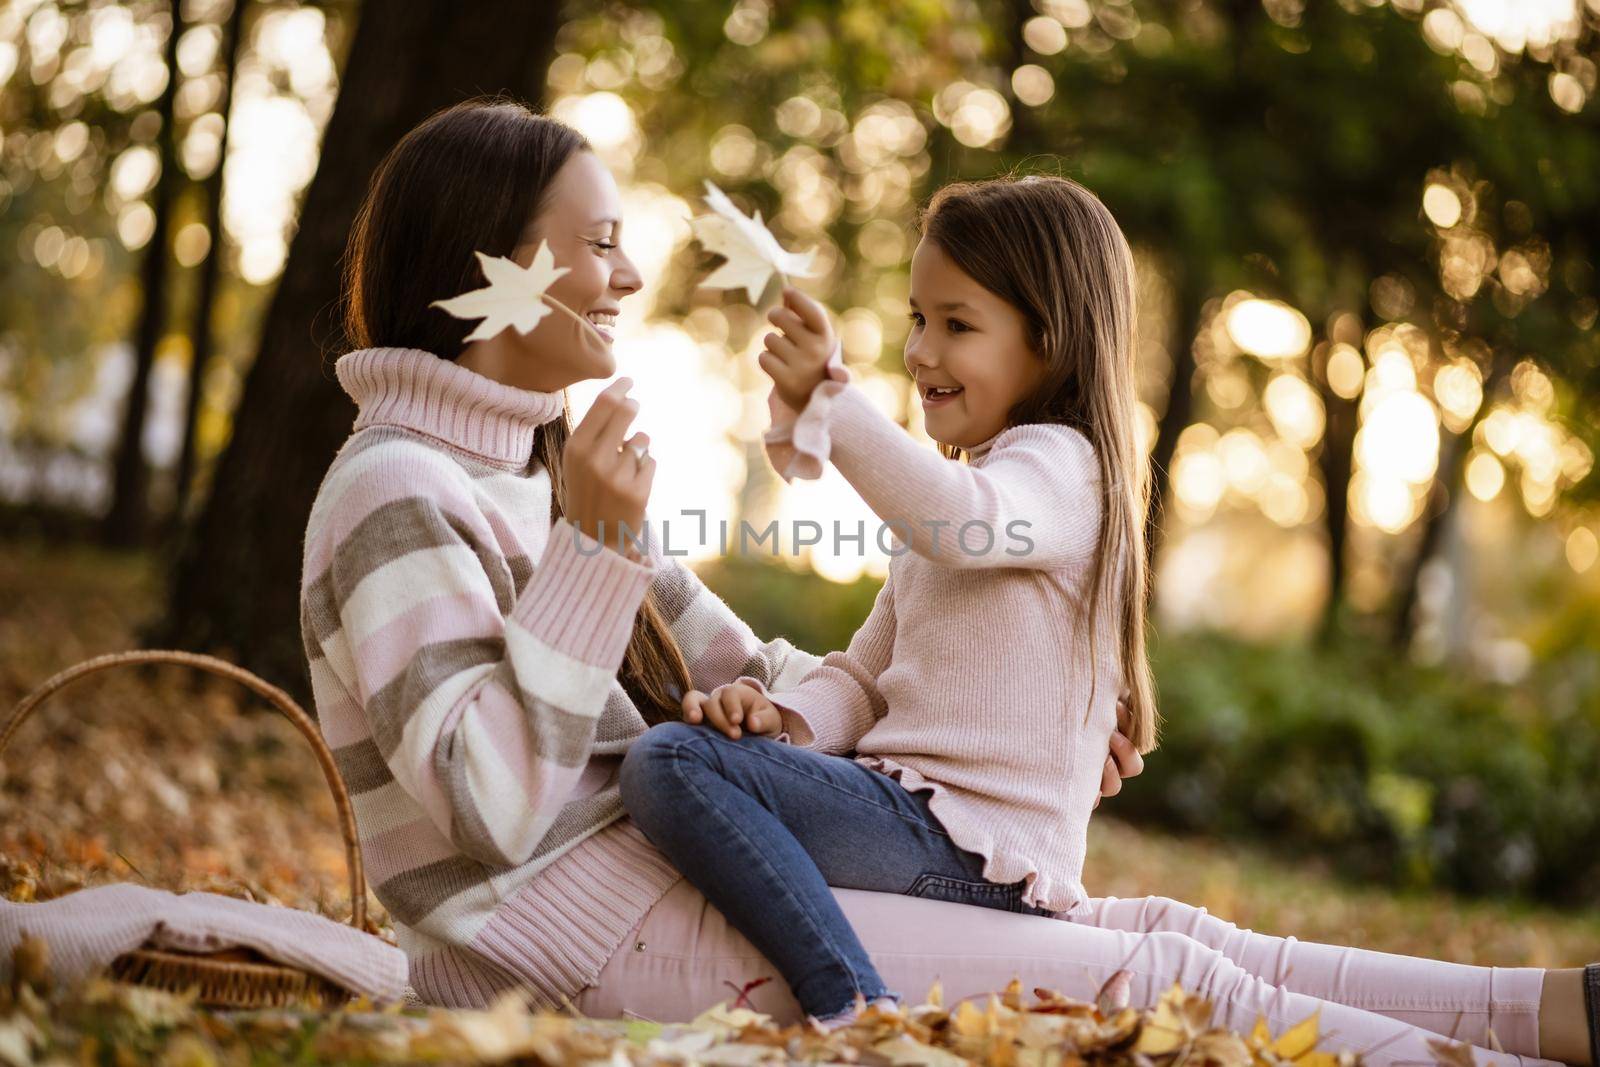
[301, 349, 819, 1006]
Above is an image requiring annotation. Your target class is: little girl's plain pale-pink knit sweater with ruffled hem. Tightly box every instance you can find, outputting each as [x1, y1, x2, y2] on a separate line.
[754, 357, 1122, 915]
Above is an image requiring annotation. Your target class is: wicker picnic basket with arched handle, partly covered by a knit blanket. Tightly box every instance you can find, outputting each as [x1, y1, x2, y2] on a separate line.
[0, 649, 366, 1008]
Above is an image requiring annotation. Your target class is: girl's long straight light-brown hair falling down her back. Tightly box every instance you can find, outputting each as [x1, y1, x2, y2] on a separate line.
[922, 176, 1158, 752]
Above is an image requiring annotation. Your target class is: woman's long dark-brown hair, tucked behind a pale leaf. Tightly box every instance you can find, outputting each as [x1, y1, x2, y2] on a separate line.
[344, 99, 690, 723]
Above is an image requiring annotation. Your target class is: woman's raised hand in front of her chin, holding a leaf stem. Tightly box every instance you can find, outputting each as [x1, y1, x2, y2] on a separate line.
[562, 378, 656, 552]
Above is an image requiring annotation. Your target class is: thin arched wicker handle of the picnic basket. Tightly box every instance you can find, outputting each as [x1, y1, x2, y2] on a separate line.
[0, 649, 366, 931]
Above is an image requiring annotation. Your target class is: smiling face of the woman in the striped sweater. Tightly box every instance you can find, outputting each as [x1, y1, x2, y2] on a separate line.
[456, 150, 643, 392]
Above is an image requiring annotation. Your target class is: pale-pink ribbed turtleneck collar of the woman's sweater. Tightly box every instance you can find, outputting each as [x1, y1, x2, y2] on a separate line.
[333, 349, 566, 467]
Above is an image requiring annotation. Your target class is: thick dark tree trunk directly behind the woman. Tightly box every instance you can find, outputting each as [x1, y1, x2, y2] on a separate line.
[156, 0, 560, 694]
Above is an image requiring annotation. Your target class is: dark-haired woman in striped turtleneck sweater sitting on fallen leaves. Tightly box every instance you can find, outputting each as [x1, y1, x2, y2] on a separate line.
[301, 102, 1582, 1059]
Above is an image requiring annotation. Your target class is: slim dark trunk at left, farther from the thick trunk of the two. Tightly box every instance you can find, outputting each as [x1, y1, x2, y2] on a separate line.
[101, 0, 184, 547]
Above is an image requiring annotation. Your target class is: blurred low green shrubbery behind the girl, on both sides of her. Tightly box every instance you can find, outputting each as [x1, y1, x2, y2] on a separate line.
[701, 558, 1600, 902]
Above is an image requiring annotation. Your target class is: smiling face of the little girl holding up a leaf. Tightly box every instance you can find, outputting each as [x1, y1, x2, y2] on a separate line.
[906, 238, 1048, 448]
